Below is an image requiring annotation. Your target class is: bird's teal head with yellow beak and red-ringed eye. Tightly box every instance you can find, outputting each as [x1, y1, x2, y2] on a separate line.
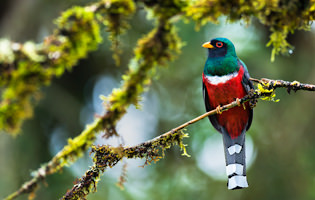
[202, 38, 236, 58]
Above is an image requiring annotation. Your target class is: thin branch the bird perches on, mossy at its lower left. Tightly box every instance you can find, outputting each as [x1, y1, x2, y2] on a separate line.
[62, 78, 315, 200]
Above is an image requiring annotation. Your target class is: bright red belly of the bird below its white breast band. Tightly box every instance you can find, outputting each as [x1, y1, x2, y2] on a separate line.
[203, 67, 250, 139]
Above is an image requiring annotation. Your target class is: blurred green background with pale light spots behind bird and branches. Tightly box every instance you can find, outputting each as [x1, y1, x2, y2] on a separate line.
[0, 0, 315, 200]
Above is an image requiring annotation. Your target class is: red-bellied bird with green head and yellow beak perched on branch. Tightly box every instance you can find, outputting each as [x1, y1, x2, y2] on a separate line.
[202, 37, 254, 190]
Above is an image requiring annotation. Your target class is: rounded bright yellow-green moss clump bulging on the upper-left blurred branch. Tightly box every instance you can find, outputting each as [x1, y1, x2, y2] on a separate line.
[51, 7, 102, 72]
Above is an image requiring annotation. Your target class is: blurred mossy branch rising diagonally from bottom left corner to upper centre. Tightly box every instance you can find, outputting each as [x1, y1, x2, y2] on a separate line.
[2, 1, 181, 199]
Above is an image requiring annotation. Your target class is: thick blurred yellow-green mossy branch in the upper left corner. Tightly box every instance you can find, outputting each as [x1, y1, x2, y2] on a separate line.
[0, 0, 134, 134]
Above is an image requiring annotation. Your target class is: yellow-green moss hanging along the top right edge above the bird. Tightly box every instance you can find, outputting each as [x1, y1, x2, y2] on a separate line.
[186, 0, 315, 61]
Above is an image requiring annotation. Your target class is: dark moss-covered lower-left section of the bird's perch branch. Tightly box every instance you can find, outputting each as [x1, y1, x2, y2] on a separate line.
[61, 130, 189, 200]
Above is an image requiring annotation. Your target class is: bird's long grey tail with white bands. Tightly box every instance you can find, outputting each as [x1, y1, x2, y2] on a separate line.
[222, 130, 248, 190]
